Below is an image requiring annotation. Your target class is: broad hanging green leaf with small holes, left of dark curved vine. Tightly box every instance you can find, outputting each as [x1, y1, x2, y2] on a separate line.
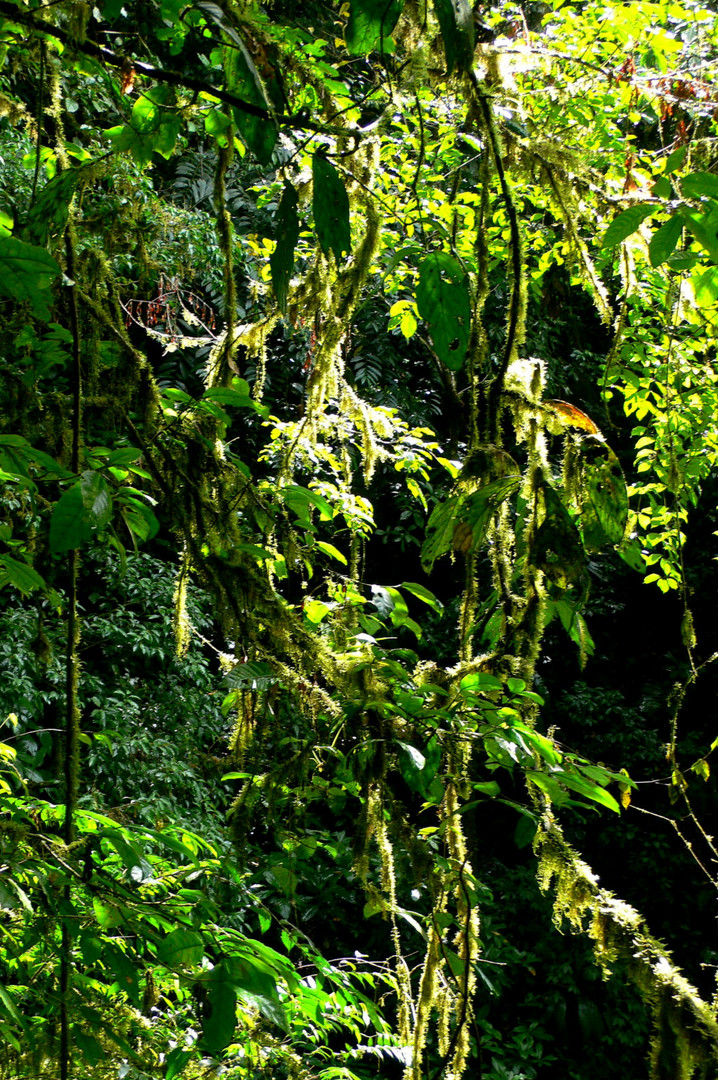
[417, 252, 471, 372]
